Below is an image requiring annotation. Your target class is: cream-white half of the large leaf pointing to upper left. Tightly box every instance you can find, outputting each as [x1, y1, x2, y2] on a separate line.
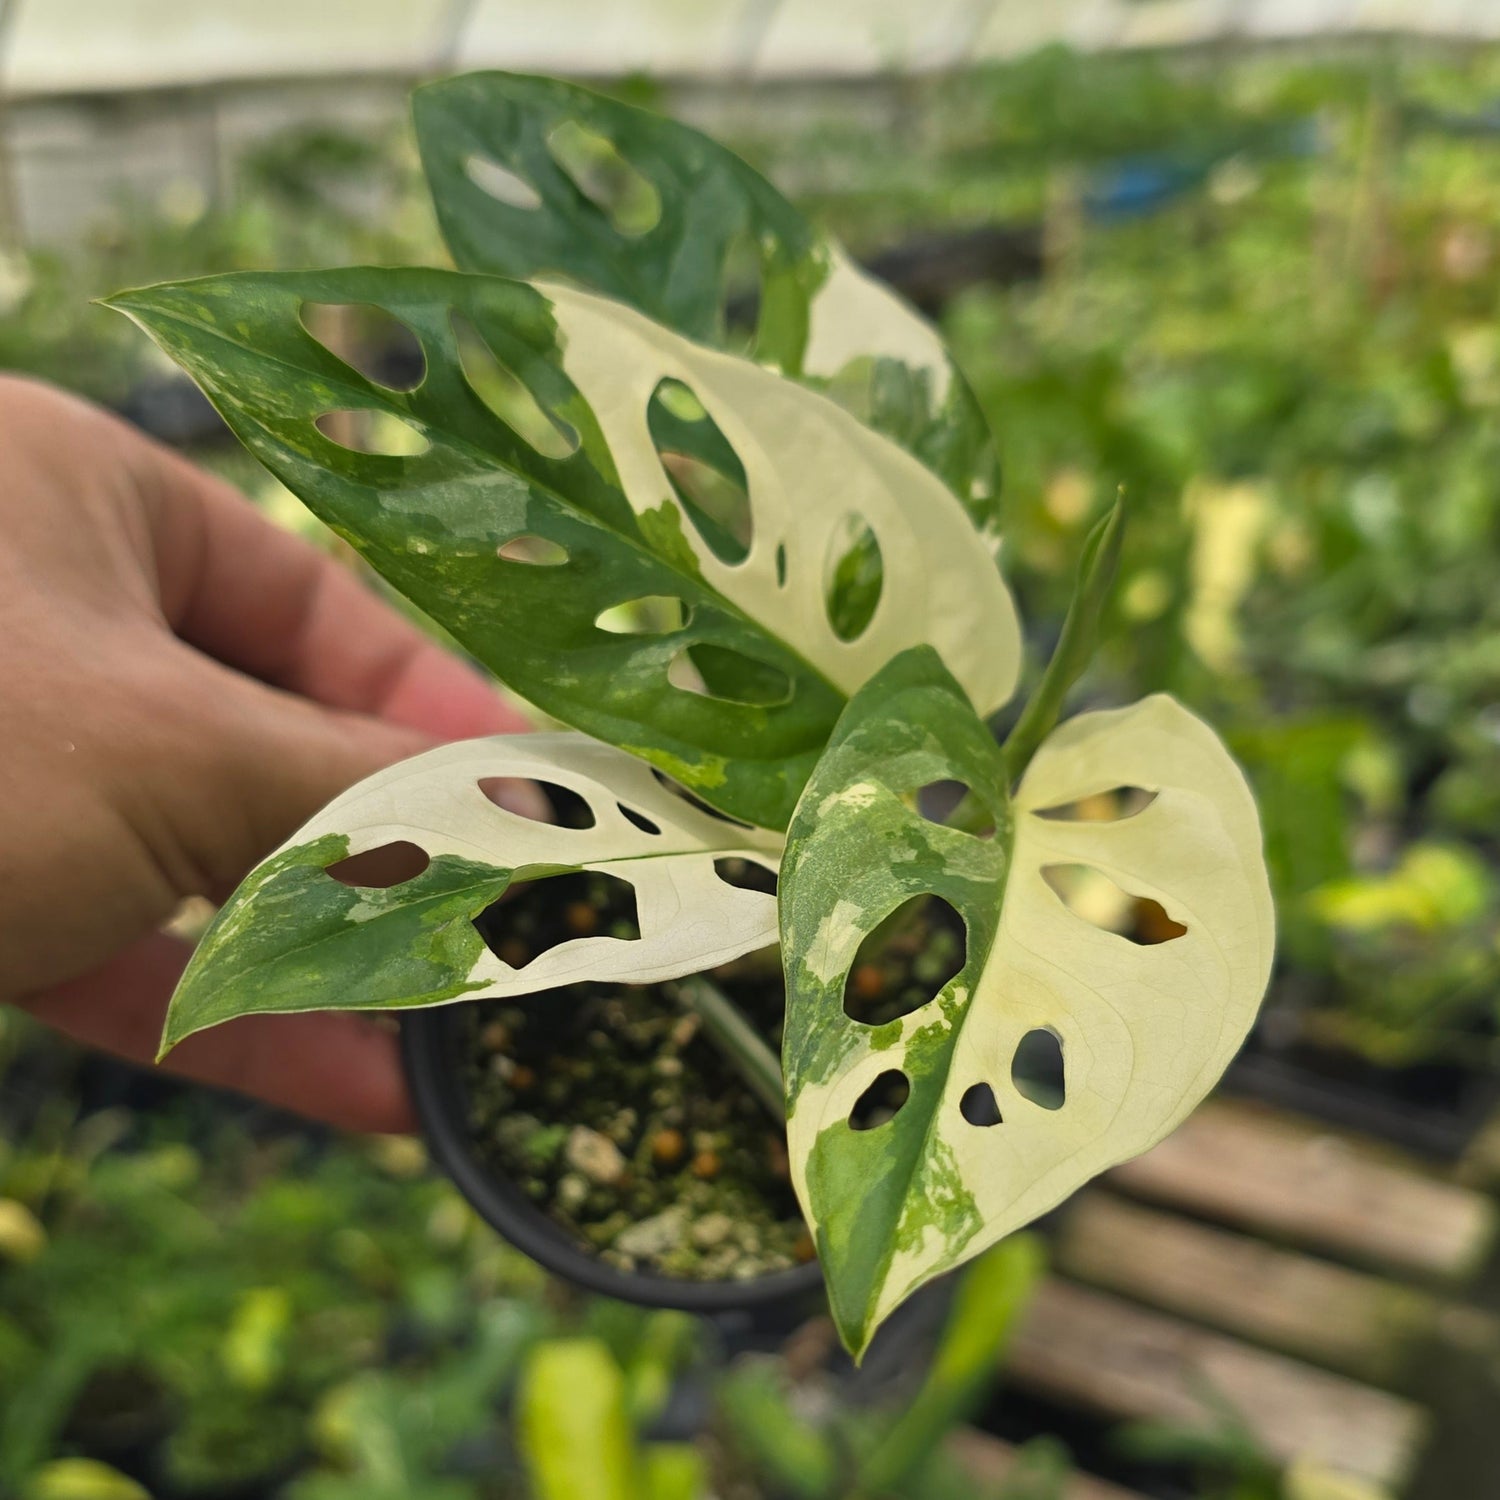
[542, 286, 1020, 713]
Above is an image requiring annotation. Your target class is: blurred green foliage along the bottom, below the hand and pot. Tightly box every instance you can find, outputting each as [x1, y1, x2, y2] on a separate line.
[0, 1017, 1065, 1500]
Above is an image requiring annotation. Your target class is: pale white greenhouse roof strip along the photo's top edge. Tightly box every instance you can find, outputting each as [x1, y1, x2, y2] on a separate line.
[0, 0, 1500, 98]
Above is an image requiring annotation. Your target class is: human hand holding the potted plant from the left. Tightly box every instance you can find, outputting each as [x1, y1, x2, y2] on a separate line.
[0, 377, 527, 1130]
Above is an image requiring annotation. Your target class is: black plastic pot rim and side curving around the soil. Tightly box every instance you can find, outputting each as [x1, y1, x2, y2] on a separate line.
[401, 1005, 824, 1313]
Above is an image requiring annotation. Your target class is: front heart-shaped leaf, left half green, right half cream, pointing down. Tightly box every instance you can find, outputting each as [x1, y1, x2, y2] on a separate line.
[782, 648, 1272, 1353]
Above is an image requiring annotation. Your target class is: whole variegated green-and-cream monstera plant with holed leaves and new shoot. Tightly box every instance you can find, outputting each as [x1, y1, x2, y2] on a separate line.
[114, 74, 1272, 1353]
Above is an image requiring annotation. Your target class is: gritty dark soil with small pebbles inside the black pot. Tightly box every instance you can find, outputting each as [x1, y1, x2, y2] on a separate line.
[459, 873, 813, 1281]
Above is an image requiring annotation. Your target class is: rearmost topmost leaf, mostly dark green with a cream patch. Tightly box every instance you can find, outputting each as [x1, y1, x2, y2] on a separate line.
[413, 74, 999, 543]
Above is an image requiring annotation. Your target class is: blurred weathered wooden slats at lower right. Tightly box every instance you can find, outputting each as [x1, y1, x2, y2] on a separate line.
[963, 1100, 1500, 1500]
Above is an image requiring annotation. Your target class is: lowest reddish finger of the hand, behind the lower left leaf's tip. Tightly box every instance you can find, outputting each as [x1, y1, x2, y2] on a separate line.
[27, 935, 414, 1131]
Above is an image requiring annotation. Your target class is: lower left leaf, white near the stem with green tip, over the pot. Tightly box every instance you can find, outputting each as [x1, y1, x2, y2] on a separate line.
[162, 734, 780, 1052]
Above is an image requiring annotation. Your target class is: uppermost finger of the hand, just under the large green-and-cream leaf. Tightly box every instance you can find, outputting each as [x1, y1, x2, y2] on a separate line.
[140, 435, 528, 740]
